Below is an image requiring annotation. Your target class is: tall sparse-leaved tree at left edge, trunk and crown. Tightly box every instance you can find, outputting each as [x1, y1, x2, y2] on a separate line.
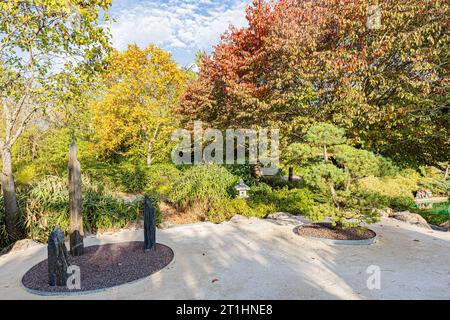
[0, 0, 111, 240]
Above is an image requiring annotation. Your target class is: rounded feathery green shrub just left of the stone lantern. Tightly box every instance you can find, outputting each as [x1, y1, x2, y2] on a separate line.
[168, 164, 239, 210]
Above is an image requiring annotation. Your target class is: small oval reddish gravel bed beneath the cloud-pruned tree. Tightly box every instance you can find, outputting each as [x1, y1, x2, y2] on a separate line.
[294, 223, 377, 240]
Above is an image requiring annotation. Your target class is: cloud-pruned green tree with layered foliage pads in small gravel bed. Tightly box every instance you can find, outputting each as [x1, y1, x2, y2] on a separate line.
[283, 123, 382, 228]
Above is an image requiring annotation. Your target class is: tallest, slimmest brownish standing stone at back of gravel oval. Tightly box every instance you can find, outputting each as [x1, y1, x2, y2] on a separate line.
[69, 141, 84, 256]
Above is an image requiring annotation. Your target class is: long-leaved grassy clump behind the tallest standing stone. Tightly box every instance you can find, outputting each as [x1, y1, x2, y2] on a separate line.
[23, 176, 142, 242]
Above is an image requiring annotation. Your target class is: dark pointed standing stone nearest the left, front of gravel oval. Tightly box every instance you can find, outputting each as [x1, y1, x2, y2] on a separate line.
[47, 228, 70, 286]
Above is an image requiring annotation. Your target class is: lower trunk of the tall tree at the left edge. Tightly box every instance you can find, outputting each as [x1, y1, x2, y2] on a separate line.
[1, 147, 21, 242]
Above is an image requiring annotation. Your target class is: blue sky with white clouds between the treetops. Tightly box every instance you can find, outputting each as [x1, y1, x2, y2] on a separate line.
[109, 0, 251, 66]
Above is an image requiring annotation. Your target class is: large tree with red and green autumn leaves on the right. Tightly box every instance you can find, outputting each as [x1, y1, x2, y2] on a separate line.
[179, 0, 450, 168]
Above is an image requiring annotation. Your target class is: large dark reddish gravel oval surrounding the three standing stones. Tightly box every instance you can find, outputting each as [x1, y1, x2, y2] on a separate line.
[22, 241, 174, 294]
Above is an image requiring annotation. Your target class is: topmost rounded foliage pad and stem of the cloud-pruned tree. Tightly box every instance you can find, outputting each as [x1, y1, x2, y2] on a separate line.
[305, 122, 346, 163]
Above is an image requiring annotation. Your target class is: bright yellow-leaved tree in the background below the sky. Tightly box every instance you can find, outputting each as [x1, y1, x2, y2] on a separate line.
[91, 44, 188, 165]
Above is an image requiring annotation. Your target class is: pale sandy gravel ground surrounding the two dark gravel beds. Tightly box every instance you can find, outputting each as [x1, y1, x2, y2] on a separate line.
[0, 218, 450, 299]
